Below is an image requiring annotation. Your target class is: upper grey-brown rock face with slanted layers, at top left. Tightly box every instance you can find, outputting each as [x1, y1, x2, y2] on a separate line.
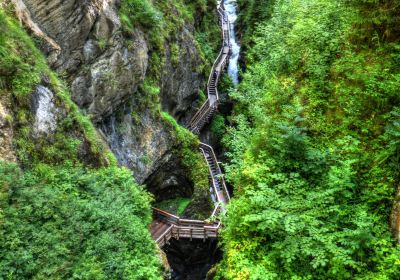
[17, 0, 148, 121]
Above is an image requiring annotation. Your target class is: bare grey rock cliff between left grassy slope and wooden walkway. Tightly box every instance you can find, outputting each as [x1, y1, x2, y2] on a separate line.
[13, 0, 209, 192]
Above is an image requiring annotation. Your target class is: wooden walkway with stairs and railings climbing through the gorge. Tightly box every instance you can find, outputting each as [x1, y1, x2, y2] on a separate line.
[150, 1, 231, 247]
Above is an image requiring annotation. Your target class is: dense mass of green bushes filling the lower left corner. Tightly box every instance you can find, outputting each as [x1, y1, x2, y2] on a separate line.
[0, 162, 161, 279]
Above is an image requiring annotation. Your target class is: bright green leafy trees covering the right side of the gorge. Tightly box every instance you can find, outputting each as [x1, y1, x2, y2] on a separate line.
[217, 0, 400, 280]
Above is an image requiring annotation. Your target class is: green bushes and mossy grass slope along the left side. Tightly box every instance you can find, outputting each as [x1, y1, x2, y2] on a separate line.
[0, 10, 161, 279]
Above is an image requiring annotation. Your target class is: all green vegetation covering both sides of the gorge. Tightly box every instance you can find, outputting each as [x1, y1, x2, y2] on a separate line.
[0, 0, 400, 280]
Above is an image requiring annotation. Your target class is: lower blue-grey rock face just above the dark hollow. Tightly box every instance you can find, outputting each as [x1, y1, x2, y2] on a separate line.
[98, 103, 174, 184]
